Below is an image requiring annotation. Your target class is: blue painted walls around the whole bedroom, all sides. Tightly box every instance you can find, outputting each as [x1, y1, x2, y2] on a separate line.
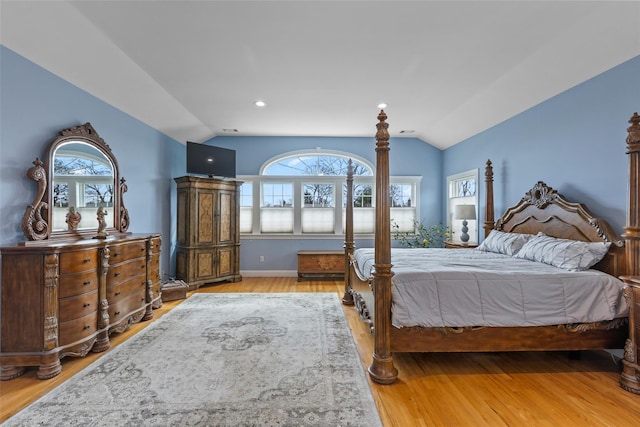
[0, 46, 640, 272]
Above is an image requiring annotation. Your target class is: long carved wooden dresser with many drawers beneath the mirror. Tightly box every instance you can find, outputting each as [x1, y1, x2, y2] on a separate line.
[0, 234, 162, 380]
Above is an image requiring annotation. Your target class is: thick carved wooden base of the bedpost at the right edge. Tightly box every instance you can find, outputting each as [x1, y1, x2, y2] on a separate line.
[620, 276, 640, 394]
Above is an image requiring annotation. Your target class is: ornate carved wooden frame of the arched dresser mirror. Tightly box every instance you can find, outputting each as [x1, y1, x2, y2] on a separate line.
[22, 122, 129, 241]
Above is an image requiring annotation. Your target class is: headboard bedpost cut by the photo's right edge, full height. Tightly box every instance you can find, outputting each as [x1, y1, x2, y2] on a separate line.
[620, 113, 640, 394]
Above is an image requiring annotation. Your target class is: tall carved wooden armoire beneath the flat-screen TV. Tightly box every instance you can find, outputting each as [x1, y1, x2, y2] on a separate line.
[175, 176, 242, 290]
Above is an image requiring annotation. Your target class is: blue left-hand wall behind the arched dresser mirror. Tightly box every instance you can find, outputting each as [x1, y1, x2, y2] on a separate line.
[0, 46, 185, 280]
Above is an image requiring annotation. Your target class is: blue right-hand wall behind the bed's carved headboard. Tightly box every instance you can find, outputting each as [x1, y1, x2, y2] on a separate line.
[442, 56, 640, 239]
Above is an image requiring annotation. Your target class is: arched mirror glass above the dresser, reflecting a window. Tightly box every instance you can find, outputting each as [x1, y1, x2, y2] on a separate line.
[51, 141, 115, 231]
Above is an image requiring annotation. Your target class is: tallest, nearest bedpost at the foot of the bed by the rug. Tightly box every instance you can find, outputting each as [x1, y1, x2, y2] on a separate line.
[369, 110, 398, 384]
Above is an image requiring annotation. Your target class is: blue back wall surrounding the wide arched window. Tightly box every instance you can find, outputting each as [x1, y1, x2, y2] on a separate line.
[206, 135, 444, 272]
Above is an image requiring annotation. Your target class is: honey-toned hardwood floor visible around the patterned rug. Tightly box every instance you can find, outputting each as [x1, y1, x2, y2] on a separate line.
[0, 277, 640, 427]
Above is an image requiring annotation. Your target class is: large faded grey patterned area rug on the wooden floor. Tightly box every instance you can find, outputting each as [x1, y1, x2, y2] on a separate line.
[4, 293, 382, 427]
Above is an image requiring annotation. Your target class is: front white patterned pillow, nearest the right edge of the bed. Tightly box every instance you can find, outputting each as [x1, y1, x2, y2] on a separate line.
[516, 232, 611, 271]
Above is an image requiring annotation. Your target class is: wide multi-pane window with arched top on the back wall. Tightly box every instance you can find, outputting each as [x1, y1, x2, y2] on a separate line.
[239, 149, 419, 236]
